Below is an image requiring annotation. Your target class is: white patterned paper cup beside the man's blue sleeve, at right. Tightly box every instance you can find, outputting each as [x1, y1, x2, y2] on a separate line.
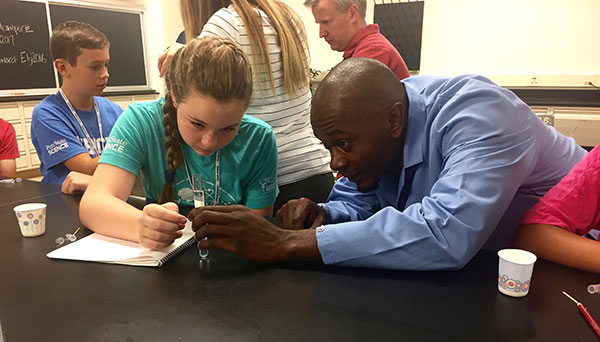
[498, 249, 537, 297]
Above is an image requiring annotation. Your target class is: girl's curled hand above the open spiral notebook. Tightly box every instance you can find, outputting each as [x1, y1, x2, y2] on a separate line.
[138, 202, 187, 249]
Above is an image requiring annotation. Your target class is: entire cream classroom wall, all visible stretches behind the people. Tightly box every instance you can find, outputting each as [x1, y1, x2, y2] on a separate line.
[5, 0, 600, 92]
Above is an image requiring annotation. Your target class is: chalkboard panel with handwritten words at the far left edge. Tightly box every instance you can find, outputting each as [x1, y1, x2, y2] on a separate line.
[0, 0, 56, 90]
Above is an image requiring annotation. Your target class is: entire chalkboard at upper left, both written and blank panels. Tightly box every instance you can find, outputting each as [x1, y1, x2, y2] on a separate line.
[0, 0, 148, 95]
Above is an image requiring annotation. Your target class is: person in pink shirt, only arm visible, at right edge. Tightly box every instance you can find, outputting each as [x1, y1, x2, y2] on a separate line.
[513, 144, 600, 273]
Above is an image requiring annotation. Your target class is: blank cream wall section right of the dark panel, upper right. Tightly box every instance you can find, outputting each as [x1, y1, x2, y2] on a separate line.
[420, 0, 600, 86]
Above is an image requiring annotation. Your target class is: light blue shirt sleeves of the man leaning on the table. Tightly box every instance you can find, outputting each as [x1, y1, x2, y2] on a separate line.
[315, 85, 535, 270]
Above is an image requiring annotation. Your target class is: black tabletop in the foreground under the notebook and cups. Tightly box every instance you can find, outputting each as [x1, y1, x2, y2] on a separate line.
[0, 181, 600, 342]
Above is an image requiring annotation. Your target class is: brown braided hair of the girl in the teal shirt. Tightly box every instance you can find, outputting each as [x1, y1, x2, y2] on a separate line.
[159, 37, 252, 203]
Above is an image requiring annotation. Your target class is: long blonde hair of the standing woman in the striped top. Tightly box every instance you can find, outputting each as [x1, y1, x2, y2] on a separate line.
[180, 0, 309, 94]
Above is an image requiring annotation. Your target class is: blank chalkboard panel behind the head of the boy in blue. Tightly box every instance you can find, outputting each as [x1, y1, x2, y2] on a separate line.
[50, 4, 147, 87]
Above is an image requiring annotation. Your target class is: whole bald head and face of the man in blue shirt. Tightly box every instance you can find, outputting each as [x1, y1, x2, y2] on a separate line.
[310, 58, 408, 191]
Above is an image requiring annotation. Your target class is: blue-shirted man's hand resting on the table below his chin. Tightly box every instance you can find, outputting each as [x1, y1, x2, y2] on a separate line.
[276, 197, 326, 229]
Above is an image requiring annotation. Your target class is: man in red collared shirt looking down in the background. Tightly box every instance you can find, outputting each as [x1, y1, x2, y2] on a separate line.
[304, 0, 410, 79]
